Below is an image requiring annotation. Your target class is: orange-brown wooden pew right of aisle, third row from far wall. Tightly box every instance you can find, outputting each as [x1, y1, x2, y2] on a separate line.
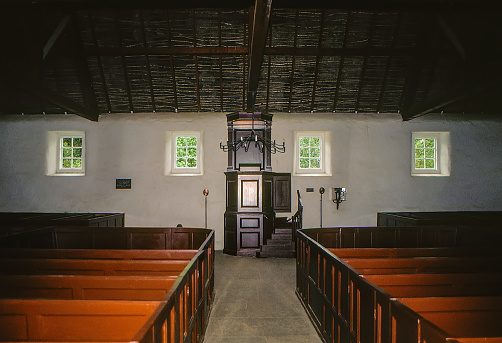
[363, 273, 502, 297]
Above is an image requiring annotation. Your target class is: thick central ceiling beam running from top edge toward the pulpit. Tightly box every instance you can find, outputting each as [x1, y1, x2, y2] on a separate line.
[247, 0, 272, 112]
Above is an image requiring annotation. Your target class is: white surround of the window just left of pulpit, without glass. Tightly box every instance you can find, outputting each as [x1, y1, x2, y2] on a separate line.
[164, 131, 203, 176]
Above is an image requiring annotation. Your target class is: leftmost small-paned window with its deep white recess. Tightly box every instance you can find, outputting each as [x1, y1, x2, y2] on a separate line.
[47, 131, 85, 176]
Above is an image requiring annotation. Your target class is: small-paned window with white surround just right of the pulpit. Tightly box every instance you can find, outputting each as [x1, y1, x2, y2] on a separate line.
[294, 132, 331, 176]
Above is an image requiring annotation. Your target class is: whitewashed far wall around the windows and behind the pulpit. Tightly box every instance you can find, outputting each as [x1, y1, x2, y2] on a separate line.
[0, 113, 502, 249]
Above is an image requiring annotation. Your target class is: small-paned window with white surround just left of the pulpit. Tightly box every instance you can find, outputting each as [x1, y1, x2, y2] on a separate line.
[165, 131, 202, 175]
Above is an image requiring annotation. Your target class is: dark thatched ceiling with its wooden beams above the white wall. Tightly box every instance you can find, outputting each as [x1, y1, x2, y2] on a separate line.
[0, 0, 502, 120]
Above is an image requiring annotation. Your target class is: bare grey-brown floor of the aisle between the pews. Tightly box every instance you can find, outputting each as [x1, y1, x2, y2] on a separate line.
[204, 251, 321, 343]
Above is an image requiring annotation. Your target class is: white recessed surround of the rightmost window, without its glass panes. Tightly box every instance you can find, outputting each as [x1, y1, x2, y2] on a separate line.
[411, 131, 450, 176]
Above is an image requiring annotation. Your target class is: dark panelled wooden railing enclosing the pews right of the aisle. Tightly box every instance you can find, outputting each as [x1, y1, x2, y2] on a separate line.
[296, 228, 502, 343]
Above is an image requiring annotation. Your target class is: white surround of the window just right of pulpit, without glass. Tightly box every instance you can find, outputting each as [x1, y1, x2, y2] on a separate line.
[293, 131, 331, 176]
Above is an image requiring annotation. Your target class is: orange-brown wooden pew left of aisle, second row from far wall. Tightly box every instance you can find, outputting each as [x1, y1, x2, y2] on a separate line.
[0, 258, 189, 276]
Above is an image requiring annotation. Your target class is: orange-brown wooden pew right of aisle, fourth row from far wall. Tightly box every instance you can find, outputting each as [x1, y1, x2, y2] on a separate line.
[397, 297, 502, 342]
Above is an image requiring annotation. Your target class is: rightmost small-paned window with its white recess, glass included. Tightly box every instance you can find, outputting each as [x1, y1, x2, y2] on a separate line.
[411, 132, 450, 176]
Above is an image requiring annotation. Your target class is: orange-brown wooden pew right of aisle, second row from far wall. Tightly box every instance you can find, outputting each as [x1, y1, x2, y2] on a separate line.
[343, 257, 502, 275]
